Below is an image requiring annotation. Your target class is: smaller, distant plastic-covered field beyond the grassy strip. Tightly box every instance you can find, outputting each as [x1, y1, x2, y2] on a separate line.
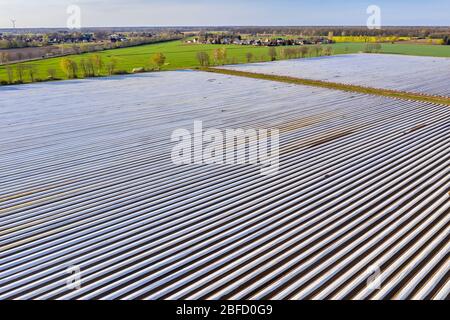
[220, 54, 450, 97]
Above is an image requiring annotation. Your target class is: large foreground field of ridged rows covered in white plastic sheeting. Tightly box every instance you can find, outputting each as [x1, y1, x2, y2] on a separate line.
[0, 71, 450, 299]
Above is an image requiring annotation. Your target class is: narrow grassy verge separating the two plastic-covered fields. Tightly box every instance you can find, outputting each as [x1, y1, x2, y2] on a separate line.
[197, 67, 450, 106]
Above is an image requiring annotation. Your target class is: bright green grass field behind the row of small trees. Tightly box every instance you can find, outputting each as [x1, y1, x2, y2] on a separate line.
[0, 41, 450, 82]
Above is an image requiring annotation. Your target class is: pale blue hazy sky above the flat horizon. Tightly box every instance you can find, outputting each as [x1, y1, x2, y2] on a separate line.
[0, 0, 450, 28]
